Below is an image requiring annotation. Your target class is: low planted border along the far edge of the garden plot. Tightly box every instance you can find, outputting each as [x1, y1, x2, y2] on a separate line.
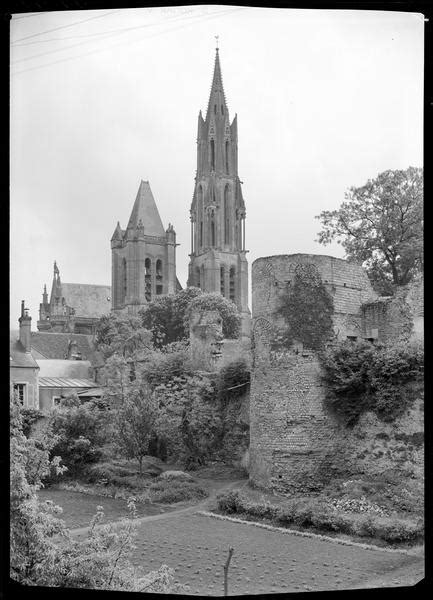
[217, 491, 424, 543]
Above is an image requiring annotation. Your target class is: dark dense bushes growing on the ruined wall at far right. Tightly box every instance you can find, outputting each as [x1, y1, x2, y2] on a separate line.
[320, 341, 424, 426]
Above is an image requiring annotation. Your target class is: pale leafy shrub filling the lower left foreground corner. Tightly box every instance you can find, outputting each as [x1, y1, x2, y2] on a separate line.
[10, 394, 182, 593]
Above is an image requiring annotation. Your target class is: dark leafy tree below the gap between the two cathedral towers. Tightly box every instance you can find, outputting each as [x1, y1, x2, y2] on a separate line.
[140, 287, 202, 349]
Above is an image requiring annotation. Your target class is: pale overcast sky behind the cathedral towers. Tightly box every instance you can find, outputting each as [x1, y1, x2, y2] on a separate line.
[10, 5, 424, 330]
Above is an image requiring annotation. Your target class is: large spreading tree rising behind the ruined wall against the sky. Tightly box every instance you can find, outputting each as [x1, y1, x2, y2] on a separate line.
[316, 167, 423, 295]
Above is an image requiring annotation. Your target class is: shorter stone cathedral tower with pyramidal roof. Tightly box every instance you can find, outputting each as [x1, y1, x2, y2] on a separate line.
[111, 181, 180, 313]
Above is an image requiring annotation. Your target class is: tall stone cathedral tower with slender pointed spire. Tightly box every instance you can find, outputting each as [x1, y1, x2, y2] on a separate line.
[188, 48, 250, 335]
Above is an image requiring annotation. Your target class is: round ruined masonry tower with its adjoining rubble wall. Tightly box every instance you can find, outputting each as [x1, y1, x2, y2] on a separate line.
[249, 254, 423, 495]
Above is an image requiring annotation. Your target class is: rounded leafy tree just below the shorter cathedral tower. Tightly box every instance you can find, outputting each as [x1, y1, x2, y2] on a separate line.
[95, 313, 152, 359]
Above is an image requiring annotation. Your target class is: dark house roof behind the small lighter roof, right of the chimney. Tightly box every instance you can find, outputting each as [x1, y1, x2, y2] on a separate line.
[31, 331, 103, 365]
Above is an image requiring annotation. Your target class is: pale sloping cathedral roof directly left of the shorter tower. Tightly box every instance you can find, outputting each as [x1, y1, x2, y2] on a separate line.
[62, 283, 111, 318]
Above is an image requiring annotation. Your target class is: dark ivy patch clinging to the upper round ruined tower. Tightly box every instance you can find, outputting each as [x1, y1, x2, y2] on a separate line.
[278, 263, 334, 350]
